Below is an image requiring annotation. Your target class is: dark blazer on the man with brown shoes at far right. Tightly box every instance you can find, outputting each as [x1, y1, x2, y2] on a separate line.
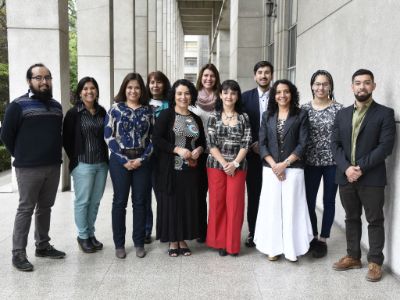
[331, 102, 396, 186]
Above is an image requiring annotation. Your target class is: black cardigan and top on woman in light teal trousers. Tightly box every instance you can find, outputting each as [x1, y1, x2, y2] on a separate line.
[63, 102, 108, 171]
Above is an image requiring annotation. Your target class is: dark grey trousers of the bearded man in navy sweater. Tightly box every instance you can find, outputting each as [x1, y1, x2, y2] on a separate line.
[13, 164, 60, 250]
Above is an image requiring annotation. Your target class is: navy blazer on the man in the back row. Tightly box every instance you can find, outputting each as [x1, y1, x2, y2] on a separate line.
[242, 88, 260, 146]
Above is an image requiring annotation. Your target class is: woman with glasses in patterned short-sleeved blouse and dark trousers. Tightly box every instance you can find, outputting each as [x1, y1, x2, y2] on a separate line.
[302, 70, 343, 258]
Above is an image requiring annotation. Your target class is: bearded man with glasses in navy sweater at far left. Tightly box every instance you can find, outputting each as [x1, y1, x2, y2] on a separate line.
[1, 64, 65, 271]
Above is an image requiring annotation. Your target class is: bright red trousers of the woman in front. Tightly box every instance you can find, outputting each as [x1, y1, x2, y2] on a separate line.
[206, 168, 246, 254]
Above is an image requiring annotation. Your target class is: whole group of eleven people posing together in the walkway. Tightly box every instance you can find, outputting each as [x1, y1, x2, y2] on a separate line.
[1, 61, 395, 281]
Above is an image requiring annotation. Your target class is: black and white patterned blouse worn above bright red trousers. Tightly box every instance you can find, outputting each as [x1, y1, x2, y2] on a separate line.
[207, 112, 251, 170]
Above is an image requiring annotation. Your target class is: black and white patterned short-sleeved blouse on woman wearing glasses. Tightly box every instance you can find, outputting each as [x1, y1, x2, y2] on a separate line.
[301, 102, 343, 166]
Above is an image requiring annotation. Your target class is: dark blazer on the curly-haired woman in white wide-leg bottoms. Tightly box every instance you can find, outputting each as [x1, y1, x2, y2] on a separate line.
[258, 109, 308, 168]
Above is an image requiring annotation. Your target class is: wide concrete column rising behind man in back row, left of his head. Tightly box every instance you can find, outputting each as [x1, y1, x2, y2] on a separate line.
[229, 0, 264, 91]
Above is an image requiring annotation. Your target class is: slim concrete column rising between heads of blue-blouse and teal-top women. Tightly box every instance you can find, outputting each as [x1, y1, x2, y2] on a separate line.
[148, 0, 157, 72]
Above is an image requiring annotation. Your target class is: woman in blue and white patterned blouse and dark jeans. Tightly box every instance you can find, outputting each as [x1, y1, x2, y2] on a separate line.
[104, 73, 154, 258]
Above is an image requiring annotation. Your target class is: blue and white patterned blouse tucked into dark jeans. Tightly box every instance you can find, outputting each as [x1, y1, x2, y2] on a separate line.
[104, 102, 154, 164]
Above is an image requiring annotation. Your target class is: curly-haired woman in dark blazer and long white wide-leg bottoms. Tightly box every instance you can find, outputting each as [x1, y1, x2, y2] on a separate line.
[254, 80, 313, 261]
